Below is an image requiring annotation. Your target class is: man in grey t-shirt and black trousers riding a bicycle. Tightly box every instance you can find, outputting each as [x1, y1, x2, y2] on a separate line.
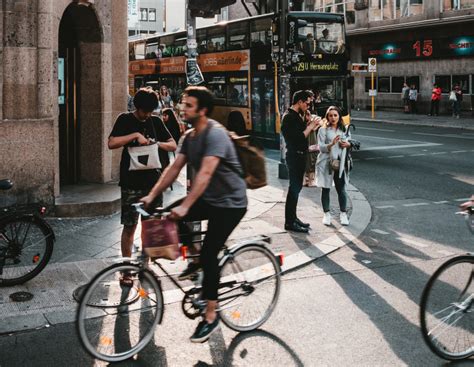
[141, 87, 247, 342]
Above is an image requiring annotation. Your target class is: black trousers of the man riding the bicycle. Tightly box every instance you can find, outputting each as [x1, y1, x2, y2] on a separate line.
[167, 199, 247, 301]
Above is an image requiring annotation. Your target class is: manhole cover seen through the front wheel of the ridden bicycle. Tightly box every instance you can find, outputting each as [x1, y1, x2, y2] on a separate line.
[72, 280, 139, 307]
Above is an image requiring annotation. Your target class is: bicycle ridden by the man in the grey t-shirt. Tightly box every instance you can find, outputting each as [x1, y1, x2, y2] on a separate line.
[77, 203, 283, 362]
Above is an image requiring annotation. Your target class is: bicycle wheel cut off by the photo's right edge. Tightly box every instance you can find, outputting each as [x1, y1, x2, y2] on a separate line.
[420, 255, 474, 360]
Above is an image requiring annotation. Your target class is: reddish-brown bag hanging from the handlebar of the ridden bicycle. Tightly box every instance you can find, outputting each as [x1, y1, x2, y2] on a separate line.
[142, 218, 179, 260]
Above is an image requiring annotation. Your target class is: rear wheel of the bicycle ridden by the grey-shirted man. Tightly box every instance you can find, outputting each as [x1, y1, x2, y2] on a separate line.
[218, 244, 281, 331]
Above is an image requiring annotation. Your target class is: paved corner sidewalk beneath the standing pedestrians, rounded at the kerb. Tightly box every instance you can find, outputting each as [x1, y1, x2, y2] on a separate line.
[0, 152, 371, 334]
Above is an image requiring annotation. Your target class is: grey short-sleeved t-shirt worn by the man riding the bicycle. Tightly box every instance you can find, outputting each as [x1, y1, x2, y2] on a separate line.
[179, 120, 247, 208]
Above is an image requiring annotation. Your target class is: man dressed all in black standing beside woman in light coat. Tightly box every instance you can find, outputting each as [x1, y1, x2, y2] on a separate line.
[281, 90, 318, 233]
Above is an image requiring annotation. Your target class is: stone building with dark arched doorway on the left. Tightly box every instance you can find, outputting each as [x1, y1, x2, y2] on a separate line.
[0, 0, 128, 210]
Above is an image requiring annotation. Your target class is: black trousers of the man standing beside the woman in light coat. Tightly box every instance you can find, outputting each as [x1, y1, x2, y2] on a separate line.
[285, 151, 306, 225]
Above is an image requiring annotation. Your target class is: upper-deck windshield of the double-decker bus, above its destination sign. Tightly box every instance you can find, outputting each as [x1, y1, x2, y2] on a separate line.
[298, 21, 345, 54]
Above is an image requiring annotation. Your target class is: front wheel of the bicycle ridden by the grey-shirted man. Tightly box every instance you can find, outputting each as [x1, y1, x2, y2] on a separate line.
[77, 263, 163, 362]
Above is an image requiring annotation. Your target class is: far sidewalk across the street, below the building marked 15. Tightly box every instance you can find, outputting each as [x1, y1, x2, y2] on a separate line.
[351, 110, 474, 130]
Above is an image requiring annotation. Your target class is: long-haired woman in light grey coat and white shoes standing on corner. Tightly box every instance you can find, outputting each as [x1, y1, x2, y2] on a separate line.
[316, 106, 351, 226]
